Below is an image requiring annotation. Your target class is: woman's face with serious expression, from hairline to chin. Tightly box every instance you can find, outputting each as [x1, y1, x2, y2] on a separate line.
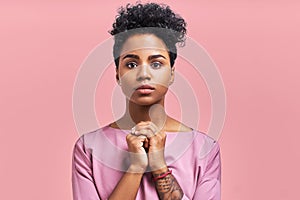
[116, 34, 174, 105]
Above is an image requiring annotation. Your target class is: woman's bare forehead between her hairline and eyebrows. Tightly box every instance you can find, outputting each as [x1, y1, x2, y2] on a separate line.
[121, 34, 167, 55]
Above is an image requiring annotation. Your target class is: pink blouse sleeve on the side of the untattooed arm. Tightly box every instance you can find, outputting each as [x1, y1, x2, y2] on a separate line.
[72, 137, 100, 200]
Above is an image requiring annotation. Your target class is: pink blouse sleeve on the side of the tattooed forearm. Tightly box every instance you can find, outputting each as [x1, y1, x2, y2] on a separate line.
[193, 142, 221, 200]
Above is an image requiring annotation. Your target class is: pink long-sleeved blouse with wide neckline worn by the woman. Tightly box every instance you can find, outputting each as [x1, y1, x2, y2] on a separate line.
[72, 126, 221, 200]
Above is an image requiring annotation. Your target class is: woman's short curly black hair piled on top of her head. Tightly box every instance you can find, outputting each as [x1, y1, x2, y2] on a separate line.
[110, 3, 186, 67]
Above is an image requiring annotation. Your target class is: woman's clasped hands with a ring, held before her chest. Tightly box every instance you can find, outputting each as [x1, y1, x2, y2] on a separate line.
[126, 121, 166, 173]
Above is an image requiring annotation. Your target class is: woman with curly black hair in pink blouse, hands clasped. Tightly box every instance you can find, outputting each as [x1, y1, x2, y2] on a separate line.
[72, 3, 220, 200]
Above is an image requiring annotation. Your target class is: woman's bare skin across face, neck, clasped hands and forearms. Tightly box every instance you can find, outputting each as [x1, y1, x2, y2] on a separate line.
[109, 34, 190, 199]
